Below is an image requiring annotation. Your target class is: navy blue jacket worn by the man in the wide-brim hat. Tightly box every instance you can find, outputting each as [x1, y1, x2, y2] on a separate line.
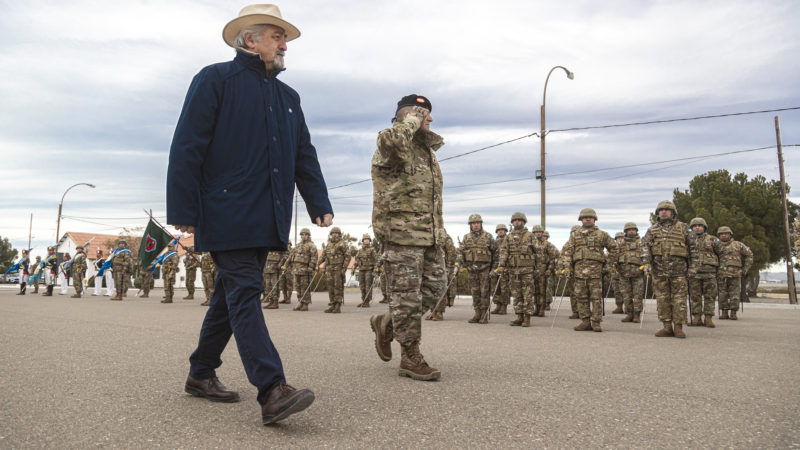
[167, 51, 333, 251]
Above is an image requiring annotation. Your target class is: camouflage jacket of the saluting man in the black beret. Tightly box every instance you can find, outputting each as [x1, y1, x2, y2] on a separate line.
[372, 118, 446, 247]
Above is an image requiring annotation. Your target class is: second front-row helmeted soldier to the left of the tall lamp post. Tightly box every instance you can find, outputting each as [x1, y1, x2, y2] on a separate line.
[459, 214, 497, 323]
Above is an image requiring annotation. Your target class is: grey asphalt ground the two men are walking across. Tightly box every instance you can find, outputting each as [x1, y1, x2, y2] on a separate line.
[0, 289, 800, 448]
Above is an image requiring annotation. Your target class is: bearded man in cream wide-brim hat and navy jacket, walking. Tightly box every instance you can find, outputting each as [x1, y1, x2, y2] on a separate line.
[167, 5, 333, 425]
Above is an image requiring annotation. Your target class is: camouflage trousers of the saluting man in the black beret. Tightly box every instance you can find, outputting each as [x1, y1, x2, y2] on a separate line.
[381, 243, 447, 346]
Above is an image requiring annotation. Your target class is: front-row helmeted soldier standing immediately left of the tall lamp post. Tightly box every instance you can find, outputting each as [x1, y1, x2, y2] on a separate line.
[493, 212, 536, 327]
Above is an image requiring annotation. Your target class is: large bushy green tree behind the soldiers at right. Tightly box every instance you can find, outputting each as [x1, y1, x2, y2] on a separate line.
[672, 170, 800, 288]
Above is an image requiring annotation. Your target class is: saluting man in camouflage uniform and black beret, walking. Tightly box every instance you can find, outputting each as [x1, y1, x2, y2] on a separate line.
[370, 101, 447, 379]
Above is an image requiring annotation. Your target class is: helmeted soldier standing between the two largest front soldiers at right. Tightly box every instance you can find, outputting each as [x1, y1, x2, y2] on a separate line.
[616, 222, 645, 323]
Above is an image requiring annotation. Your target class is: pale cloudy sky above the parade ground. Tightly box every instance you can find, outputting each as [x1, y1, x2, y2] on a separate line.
[0, 0, 800, 254]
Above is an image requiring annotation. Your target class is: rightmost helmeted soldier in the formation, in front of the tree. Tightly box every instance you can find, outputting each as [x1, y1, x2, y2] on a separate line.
[717, 226, 753, 320]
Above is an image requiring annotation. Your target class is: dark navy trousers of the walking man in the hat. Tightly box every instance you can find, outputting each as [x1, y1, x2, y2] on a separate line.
[189, 248, 286, 405]
